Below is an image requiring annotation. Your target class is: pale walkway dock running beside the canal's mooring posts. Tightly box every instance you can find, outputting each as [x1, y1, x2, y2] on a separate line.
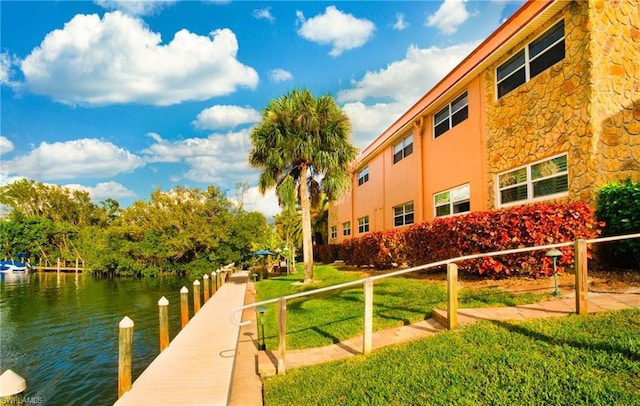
[115, 271, 249, 406]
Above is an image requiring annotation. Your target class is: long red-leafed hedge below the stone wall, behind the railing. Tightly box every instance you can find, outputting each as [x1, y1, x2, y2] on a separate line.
[405, 203, 599, 276]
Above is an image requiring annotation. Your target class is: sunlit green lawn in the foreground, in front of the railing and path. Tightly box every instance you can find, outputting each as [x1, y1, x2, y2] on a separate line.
[264, 309, 640, 406]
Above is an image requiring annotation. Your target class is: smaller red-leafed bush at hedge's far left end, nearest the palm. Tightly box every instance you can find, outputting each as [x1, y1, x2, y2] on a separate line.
[340, 230, 404, 269]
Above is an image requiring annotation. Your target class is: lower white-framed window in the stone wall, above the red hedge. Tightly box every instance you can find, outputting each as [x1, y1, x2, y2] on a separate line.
[498, 154, 569, 205]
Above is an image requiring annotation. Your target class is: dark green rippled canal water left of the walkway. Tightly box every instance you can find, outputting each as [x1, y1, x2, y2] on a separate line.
[0, 272, 193, 406]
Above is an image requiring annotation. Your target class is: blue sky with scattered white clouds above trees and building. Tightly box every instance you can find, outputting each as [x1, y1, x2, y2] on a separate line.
[0, 0, 522, 216]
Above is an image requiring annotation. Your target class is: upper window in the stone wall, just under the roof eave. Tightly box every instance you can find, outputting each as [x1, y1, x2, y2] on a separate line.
[496, 20, 564, 98]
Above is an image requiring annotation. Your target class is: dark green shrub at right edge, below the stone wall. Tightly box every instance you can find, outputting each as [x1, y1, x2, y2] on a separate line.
[596, 179, 640, 269]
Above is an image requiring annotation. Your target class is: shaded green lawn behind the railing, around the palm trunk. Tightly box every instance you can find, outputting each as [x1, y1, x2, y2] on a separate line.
[256, 265, 552, 349]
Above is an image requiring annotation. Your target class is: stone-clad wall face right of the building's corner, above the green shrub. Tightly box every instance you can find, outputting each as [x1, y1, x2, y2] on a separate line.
[585, 0, 640, 198]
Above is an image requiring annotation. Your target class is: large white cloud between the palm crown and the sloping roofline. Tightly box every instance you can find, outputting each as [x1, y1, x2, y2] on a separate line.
[337, 44, 476, 148]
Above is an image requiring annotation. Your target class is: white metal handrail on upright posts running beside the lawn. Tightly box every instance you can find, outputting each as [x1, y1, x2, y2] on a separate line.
[230, 233, 640, 374]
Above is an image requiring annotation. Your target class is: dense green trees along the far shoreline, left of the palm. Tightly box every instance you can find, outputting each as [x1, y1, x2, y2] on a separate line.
[0, 179, 272, 276]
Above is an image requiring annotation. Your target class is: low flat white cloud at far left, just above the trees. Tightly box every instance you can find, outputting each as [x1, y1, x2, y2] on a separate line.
[2, 138, 144, 180]
